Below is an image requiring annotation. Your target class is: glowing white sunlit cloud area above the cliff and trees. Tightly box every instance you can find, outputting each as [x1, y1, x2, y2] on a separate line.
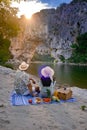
[12, 1, 50, 19]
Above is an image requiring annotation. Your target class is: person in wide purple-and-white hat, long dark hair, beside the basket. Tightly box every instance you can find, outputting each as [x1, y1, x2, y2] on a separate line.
[40, 66, 56, 97]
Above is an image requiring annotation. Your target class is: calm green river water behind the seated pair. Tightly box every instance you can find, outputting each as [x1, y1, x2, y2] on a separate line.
[28, 63, 87, 89]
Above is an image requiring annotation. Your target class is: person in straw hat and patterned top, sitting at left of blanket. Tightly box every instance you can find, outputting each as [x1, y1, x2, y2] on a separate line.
[14, 61, 39, 96]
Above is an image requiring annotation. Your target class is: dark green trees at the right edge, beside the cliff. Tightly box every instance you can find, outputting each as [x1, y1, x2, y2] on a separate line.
[69, 33, 87, 63]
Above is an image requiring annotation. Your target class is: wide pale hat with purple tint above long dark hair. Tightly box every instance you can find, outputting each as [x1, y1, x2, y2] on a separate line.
[41, 66, 54, 79]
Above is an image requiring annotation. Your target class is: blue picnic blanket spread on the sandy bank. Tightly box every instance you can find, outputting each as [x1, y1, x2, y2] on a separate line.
[10, 92, 76, 106]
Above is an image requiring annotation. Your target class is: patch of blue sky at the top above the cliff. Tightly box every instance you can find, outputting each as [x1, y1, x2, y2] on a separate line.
[39, 0, 72, 7]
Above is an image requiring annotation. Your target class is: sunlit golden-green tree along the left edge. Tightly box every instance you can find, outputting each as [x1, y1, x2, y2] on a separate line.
[0, 0, 20, 65]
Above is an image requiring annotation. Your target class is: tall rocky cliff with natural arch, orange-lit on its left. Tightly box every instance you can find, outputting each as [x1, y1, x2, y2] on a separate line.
[10, 0, 87, 62]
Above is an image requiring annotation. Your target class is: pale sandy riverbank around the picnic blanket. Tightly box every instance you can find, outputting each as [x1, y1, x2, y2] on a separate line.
[0, 66, 87, 130]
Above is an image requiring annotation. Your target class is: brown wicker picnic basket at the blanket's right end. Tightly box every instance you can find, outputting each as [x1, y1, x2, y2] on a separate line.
[58, 88, 72, 100]
